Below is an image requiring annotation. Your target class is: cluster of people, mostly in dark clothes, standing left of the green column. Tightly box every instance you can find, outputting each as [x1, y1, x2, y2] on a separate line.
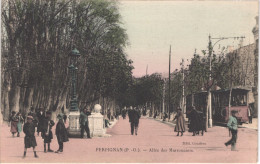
[10, 108, 69, 158]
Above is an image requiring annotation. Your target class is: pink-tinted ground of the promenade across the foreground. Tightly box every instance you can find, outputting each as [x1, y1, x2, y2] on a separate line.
[0, 118, 257, 163]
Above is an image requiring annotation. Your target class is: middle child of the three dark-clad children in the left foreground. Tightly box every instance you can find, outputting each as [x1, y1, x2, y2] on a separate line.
[41, 111, 55, 153]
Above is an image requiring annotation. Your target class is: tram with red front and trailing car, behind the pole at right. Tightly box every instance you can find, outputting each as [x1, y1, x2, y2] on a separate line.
[186, 87, 250, 123]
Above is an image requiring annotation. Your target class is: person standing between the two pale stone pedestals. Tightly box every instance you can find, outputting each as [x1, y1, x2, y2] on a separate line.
[79, 108, 91, 139]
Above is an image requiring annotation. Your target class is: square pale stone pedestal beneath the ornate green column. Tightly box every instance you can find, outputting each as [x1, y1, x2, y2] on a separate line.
[68, 111, 80, 137]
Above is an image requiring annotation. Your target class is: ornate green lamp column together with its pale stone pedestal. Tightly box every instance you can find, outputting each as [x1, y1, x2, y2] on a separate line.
[68, 48, 80, 136]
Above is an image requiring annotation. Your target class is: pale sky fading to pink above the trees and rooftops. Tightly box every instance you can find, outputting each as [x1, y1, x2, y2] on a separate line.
[119, 0, 258, 77]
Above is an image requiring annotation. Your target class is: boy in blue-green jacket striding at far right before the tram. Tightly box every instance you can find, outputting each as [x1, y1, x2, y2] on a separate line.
[225, 110, 237, 151]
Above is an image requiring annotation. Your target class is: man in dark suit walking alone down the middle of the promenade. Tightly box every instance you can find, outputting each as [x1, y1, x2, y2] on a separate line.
[128, 107, 141, 135]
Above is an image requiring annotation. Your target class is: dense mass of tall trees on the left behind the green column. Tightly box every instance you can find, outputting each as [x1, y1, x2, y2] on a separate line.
[1, 0, 133, 119]
